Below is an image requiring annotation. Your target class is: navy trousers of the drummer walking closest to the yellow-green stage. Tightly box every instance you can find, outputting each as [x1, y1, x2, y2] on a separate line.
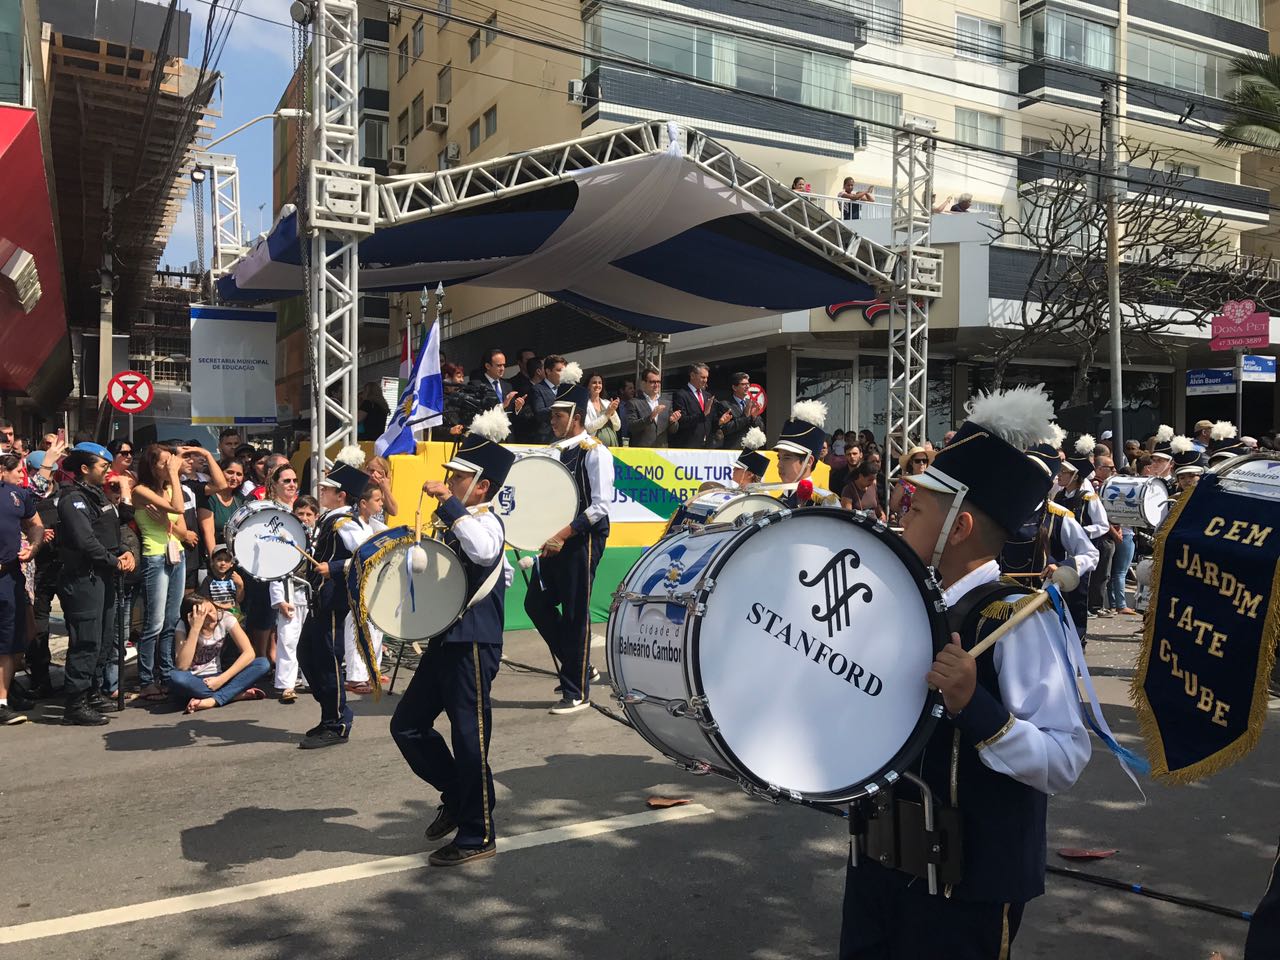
[525, 530, 608, 700]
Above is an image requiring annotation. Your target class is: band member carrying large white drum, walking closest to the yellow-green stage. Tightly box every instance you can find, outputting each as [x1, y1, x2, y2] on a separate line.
[525, 364, 613, 714]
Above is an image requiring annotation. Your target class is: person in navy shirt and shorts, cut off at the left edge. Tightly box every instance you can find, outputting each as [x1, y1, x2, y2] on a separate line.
[0, 455, 45, 726]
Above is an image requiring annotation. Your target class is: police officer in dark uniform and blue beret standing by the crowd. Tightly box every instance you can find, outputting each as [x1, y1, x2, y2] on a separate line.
[58, 443, 133, 727]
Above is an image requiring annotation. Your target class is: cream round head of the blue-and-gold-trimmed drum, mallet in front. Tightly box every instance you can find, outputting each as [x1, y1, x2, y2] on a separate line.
[365, 540, 467, 640]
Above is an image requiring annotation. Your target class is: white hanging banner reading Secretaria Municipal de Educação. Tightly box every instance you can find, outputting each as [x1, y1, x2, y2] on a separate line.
[191, 303, 276, 425]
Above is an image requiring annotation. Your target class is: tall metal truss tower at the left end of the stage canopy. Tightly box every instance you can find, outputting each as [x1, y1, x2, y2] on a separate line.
[303, 0, 378, 483]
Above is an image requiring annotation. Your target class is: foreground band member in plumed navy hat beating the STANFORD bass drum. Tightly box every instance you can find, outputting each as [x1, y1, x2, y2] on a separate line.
[840, 387, 1089, 960]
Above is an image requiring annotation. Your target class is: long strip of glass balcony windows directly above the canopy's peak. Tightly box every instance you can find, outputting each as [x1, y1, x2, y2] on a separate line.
[585, 8, 854, 114]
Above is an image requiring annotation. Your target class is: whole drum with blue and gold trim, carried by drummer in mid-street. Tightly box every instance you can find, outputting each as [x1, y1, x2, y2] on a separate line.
[348, 526, 467, 640]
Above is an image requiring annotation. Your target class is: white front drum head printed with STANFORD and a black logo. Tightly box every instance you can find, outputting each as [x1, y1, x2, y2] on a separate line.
[690, 507, 947, 803]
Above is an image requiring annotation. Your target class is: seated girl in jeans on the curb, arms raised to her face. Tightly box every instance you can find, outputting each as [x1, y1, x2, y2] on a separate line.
[169, 595, 271, 713]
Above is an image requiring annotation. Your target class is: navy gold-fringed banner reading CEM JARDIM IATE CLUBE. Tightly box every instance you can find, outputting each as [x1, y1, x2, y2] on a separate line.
[1130, 468, 1280, 783]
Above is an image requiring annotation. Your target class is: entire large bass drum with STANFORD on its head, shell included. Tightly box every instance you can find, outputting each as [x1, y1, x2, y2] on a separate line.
[608, 507, 947, 803]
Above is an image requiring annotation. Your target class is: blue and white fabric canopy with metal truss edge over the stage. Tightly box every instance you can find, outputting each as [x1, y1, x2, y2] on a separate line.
[218, 122, 897, 332]
